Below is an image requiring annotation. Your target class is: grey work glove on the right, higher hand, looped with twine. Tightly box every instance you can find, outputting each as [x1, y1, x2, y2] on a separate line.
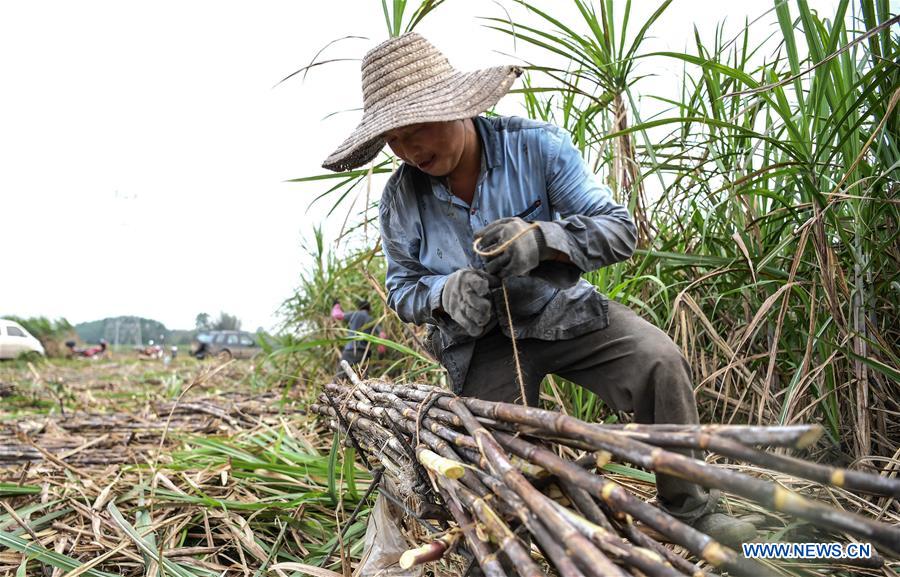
[475, 216, 555, 278]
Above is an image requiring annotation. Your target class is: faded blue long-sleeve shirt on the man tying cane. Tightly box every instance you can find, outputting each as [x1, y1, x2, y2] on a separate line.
[380, 117, 636, 387]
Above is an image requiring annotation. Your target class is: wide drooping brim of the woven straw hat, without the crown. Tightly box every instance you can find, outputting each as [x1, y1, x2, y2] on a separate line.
[322, 66, 522, 172]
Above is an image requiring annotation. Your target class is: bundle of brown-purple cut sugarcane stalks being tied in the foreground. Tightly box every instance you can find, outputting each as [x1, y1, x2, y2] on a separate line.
[312, 367, 900, 577]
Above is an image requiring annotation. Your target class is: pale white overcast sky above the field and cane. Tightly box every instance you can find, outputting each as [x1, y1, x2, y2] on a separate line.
[0, 0, 848, 330]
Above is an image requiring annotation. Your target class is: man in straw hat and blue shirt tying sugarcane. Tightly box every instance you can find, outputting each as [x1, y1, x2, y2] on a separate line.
[323, 33, 755, 546]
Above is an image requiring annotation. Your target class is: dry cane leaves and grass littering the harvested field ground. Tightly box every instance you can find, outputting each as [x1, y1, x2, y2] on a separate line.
[0, 358, 900, 577]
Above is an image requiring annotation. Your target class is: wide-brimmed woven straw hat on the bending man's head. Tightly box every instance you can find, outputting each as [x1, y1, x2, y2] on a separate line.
[322, 32, 522, 171]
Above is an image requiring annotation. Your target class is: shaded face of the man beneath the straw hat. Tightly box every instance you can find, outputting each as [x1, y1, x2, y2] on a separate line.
[383, 120, 466, 176]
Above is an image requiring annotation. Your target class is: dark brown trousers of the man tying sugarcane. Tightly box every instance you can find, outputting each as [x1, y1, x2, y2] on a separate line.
[462, 301, 718, 524]
